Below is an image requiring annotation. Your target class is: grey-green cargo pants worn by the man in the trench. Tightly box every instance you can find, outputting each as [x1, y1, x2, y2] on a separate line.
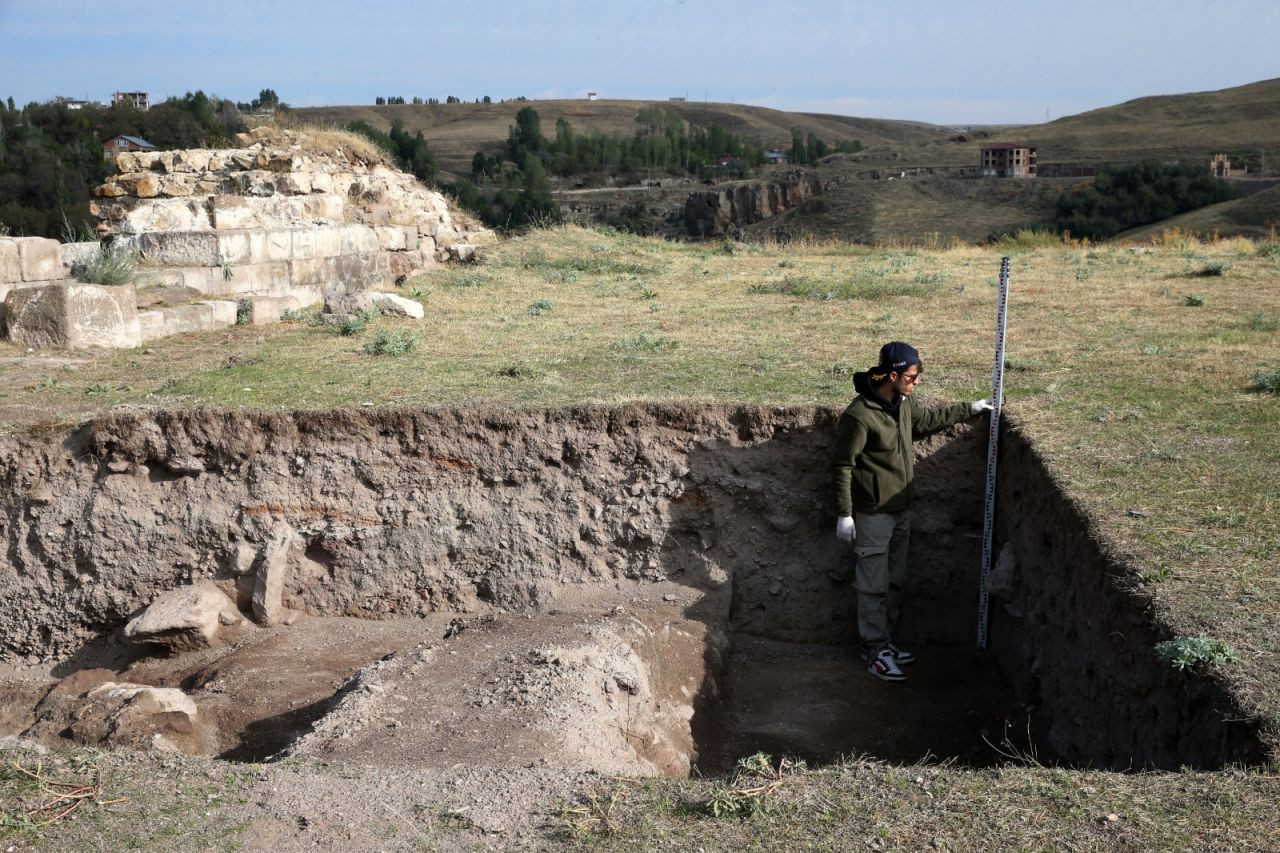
[854, 510, 911, 660]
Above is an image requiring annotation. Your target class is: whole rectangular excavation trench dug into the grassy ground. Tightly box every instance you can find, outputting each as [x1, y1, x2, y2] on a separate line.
[0, 405, 1265, 775]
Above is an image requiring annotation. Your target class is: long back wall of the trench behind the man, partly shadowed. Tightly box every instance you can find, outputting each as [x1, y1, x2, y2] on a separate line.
[0, 406, 980, 660]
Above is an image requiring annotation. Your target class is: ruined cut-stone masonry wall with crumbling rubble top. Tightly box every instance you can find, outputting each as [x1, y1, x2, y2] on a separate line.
[0, 128, 494, 347]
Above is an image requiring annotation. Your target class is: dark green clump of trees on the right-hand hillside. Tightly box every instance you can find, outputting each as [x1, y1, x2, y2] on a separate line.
[1053, 160, 1235, 240]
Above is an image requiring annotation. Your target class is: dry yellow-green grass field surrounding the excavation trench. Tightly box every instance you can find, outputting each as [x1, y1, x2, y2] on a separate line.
[0, 228, 1280, 849]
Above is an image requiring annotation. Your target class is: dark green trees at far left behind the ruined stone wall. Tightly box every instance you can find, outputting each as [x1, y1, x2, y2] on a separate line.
[0, 90, 254, 237]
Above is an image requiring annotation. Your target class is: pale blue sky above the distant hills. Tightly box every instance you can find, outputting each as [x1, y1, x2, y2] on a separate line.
[0, 0, 1280, 124]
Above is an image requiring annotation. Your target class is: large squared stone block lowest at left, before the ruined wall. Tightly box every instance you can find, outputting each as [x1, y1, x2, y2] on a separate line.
[4, 282, 142, 350]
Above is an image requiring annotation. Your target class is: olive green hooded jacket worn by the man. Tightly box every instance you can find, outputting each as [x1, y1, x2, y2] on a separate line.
[831, 374, 972, 515]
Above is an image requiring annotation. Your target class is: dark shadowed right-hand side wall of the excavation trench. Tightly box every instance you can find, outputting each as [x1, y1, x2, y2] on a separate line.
[991, 429, 1266, 770]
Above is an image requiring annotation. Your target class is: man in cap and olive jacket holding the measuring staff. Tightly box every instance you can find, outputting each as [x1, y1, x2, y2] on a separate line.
[831, 341, 991, 681]
